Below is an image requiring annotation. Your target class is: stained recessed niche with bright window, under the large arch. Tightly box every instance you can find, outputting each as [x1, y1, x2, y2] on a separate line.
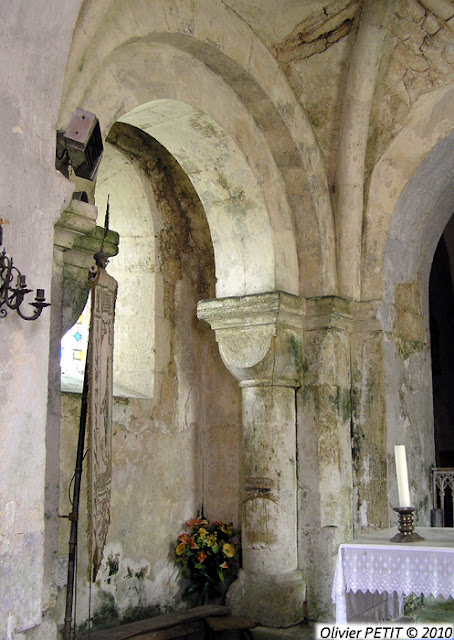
[59, 124, 241, 626]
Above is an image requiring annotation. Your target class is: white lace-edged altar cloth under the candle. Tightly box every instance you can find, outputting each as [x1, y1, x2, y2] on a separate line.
[332, 527, 454, 624]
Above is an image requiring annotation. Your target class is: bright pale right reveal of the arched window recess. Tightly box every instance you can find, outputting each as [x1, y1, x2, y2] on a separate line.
[95, 144, 156, 398]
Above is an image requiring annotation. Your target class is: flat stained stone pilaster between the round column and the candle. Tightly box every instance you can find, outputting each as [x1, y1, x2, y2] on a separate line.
[298, 296, 353, 620]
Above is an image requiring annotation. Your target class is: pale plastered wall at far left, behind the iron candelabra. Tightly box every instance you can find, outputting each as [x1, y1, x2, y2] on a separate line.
[0, 0, 78, 638]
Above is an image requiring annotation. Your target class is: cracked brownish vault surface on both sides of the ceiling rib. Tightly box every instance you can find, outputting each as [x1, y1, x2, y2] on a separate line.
[270, 0, 454, 202]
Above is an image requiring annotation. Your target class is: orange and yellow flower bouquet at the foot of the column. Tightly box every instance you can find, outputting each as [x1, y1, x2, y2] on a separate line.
[175, 518, 240, 602]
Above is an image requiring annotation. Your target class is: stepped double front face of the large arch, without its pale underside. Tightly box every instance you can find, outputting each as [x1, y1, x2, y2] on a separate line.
[60, 0, 336, 296]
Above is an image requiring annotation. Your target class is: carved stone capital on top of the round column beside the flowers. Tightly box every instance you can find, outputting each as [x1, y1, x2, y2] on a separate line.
[197, 291, 305, 387]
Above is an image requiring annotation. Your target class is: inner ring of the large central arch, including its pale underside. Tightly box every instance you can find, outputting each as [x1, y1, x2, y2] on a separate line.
[65, 40, 298, 297]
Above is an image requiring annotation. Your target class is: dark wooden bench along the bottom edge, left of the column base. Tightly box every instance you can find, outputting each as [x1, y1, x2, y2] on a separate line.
[82, 605, 228, 640]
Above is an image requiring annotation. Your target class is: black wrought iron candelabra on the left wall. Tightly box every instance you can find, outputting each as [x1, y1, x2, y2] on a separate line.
[0, 218, 50, 320]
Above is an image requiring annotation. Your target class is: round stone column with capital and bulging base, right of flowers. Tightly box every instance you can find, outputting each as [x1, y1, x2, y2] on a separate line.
[198, 292, 305, 627]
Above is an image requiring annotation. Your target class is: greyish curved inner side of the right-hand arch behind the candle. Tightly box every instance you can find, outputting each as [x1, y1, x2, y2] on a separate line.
[382, 124, 454, 523]
